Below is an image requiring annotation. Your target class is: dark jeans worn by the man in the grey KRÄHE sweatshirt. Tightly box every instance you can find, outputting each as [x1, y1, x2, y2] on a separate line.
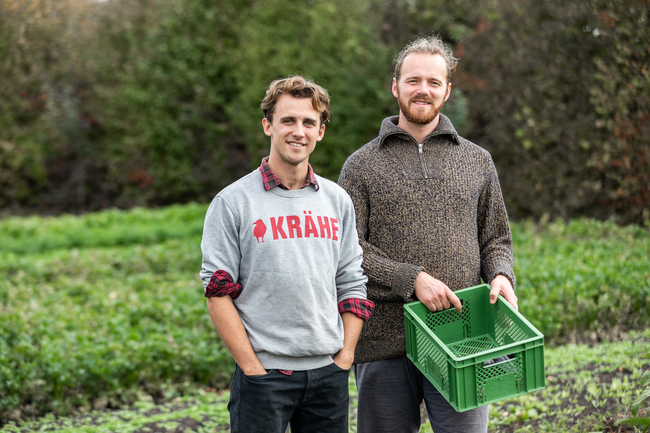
[228, 363, 350, 433]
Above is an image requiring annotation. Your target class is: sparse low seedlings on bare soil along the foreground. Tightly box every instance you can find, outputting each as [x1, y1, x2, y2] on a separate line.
[0, 329, 650, 433]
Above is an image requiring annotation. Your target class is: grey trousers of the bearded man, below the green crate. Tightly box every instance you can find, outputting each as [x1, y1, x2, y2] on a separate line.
[352, 357, 489, 433]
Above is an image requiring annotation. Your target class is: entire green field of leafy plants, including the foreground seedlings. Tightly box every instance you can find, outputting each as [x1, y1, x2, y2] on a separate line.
[0, 204, 650, 432]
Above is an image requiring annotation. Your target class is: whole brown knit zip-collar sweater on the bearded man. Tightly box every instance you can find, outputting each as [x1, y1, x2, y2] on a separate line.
[339, 114, 515, 363]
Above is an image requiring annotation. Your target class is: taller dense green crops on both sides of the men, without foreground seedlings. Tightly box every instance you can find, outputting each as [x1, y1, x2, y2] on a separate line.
[0, 204, 650, 420]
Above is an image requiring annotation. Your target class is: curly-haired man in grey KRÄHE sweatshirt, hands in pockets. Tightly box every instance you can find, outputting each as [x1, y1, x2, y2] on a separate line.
[200, 76, 373, 433]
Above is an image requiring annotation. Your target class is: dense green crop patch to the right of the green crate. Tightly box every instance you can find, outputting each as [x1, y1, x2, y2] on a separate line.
[512, 219, 650, 343]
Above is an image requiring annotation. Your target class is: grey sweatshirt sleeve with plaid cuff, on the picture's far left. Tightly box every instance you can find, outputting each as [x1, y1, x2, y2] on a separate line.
[199, 196, 241, 296]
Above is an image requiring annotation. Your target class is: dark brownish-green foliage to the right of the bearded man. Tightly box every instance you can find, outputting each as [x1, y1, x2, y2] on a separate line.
[461, 0, 650, 222]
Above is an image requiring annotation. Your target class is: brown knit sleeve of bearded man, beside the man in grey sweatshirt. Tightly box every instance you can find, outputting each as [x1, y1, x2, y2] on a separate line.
[339, 155, 425, 302]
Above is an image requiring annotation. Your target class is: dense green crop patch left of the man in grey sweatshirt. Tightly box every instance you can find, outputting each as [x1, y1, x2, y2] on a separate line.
[0, 205, 234, 418]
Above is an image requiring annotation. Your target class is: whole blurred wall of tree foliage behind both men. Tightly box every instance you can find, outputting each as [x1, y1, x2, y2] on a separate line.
[0, 0, 650, 222]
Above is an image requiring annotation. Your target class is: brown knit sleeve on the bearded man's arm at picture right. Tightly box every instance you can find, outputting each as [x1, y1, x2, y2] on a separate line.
[478, 154, 516, 288]
